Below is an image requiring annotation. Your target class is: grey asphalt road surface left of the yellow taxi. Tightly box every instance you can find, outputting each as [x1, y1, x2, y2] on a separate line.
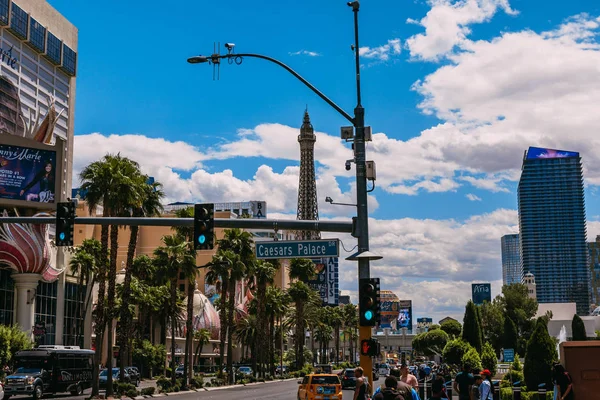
[11, 380, 310, 400]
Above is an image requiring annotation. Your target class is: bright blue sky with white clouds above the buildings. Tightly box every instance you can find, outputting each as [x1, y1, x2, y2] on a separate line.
[50, 0, 600, 317]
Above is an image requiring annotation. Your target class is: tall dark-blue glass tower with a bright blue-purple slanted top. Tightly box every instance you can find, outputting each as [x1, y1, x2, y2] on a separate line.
[518, 147, 590, 315]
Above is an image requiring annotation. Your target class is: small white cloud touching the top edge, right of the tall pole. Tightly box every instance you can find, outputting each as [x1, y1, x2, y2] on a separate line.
[406, 0, 516, 61]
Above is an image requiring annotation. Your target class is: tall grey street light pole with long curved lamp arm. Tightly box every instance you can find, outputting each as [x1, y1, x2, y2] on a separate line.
[188, 0, 372, 387]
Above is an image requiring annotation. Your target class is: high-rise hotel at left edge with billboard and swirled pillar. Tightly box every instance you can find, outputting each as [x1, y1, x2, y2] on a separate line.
[0, 0, 81, 344]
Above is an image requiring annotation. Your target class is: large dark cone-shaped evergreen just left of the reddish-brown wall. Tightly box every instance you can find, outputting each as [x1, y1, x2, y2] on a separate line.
[524, 318, 558, 390]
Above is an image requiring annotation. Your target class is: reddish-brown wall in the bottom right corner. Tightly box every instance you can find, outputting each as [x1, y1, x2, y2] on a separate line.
[560, 340, 600, 400]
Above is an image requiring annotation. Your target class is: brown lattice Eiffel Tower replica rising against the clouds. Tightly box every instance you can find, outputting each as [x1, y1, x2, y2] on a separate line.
[296, 109, 321, 240]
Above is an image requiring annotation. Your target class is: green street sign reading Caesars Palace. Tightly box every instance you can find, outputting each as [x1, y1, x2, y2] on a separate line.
[256, 239, 340, 260]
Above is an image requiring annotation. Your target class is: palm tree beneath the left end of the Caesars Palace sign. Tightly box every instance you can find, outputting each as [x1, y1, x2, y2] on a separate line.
[254, 261, 277, 378]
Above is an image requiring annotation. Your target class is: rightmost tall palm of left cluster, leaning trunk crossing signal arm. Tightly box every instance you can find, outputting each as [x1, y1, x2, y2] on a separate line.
[117, 178, 165, 379]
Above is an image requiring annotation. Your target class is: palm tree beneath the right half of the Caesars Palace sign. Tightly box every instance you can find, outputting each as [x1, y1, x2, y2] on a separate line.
[288, 258, 316, 369]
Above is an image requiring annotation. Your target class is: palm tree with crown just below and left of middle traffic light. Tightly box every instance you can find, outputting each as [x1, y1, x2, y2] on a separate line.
[154, 234, 196, 384]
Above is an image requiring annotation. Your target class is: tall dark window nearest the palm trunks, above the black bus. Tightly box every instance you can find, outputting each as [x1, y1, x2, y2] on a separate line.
[63, 282, 87, 347]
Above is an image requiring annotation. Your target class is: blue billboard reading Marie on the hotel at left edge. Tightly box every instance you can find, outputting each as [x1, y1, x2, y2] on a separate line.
[0, 144, 56, 203]
